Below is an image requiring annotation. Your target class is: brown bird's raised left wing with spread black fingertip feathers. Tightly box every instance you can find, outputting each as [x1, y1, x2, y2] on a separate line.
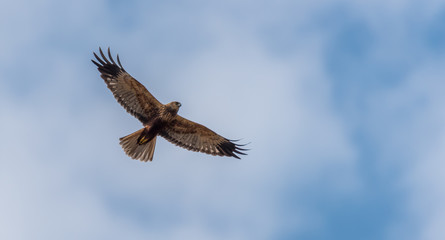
[91, 48, 162, 123]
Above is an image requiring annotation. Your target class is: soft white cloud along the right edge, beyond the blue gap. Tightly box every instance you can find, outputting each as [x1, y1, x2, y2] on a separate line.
[375, 59, 445, 239]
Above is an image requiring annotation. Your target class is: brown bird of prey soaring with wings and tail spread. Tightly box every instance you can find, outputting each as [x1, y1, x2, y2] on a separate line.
[91, 48, 246, 162]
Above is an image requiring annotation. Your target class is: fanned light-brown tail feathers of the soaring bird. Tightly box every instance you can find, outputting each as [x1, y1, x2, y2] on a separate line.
[119, 128, 156, 162]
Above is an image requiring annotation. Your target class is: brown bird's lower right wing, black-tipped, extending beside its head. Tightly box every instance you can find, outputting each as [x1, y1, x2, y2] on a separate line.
[159, 115, 246, 159]
